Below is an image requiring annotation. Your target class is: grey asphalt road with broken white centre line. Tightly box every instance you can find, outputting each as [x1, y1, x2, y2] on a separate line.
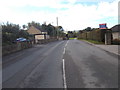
[3, 40, 118, 88]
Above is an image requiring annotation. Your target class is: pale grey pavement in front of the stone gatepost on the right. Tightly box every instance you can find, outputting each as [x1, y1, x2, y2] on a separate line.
[81, 41, 120, 55]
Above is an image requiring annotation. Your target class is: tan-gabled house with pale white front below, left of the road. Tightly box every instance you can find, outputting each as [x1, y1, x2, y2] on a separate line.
[27, 26, 50, 43]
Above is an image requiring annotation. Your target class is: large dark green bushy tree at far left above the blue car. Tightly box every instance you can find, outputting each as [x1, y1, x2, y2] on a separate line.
[2, 22, 29, 45]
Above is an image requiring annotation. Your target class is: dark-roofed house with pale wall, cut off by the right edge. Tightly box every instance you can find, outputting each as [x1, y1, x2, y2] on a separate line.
[111, 24, 120, 40]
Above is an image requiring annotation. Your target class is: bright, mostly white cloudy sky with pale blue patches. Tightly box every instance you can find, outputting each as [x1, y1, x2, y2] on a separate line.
[0, 0, 119, 31]
